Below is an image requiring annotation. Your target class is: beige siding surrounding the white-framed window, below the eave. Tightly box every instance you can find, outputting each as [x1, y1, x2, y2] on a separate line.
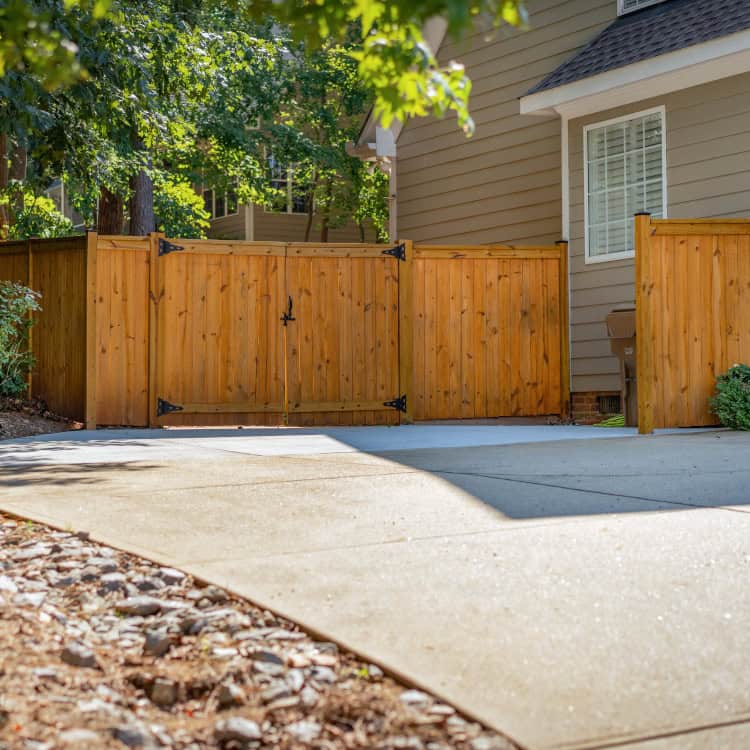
[569, 74, 750, 391]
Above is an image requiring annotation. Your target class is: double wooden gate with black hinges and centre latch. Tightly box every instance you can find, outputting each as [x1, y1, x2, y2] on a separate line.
[151, 239, 401, 424]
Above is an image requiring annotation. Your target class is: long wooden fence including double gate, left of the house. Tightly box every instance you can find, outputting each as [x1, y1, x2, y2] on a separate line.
[0, 233, 569, 426]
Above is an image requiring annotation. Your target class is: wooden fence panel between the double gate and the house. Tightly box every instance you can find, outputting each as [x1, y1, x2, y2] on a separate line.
[413, 244, 567, 420]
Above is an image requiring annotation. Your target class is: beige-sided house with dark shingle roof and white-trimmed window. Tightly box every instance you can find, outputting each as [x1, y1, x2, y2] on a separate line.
[361, 0, 750, 419]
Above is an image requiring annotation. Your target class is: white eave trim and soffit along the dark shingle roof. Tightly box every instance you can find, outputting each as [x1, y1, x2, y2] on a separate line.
[520, 30, 750, 119]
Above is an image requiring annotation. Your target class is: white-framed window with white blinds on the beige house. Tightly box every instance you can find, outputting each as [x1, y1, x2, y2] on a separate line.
[583, 107, 667, 263]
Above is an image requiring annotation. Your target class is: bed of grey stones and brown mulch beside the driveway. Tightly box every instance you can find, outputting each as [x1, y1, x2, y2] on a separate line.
[0, 513, 516, 750]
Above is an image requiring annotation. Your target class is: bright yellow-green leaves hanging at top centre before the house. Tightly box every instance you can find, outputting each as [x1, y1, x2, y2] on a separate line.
[237, 0, 527, 135]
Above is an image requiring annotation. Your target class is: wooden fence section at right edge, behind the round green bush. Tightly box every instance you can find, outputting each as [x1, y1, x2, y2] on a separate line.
[636, 215, 750, 433]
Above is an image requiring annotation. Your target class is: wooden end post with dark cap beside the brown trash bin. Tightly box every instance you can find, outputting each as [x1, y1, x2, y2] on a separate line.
[635, 213, 654, 435]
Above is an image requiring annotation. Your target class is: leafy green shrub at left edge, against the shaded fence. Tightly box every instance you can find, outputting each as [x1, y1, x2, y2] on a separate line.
[0, 281, 41, 396]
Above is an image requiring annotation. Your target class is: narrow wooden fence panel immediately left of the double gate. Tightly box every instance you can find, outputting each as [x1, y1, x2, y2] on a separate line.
[96, 237, 149, 427]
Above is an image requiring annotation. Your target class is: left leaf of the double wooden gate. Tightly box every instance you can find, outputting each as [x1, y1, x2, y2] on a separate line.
[151, 240, 286, 425]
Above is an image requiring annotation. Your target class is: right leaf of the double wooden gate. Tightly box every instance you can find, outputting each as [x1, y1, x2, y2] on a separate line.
[286, 245, 400, 425]
